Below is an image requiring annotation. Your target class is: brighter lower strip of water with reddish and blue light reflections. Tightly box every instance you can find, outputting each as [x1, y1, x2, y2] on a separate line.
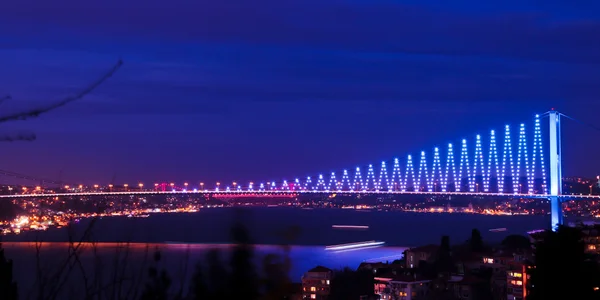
[3, 242, 406, 286]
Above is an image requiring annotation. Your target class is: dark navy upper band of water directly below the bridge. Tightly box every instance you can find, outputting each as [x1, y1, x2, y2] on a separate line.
[5, 207, 550, 247]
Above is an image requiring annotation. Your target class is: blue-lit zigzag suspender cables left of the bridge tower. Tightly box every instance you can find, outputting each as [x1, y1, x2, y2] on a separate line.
[244, 115, 548, 194]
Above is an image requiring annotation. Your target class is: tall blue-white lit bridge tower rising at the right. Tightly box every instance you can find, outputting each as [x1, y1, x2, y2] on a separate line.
[548, 110, 563, 231]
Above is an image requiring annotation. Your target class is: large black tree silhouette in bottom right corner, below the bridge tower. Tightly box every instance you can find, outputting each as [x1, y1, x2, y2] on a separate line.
[527, 226, 600, 300]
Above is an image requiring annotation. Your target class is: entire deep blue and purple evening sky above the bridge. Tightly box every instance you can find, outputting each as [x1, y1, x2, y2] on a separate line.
[0, 0, 600, 183]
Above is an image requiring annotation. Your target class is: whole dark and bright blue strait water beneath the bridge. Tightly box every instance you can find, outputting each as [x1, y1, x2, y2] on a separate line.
[4, 207, 549, 296]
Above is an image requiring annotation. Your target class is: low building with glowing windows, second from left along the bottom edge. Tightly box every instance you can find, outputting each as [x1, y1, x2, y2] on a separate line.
[374, 274, 431, 300]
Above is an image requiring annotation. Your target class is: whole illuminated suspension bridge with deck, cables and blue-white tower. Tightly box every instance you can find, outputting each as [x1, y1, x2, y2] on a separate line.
[0, 110, 600, 229]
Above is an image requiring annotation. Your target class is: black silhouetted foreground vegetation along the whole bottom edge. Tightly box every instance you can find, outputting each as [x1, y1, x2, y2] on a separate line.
[0, 222, 600, 300]
